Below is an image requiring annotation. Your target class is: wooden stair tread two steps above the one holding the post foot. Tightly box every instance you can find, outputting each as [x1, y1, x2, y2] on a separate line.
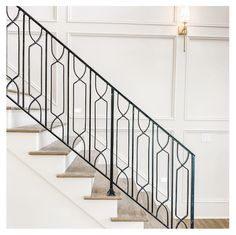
[29, 136, 76, 155]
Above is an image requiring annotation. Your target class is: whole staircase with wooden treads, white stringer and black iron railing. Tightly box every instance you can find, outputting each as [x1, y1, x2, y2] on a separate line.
[6, 7, 195, 228]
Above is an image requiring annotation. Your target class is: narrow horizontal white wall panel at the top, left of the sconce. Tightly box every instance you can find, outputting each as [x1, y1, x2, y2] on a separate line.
[67, 6, 176, 25]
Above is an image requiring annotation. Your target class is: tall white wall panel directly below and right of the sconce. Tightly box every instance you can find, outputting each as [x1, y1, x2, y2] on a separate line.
[185, 37, 229, 120]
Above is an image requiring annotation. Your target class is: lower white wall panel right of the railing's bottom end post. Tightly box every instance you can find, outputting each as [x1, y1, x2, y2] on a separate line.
[184, 130, 229, 218]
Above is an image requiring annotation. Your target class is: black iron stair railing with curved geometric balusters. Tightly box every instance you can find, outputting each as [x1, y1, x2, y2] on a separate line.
[7, 7, 195, 228]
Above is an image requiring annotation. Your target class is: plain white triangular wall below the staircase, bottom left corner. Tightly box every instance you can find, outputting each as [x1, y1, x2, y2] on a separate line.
[7, 151, 101, 228]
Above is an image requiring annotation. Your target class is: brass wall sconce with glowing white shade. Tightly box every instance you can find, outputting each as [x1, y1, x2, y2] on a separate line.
[178, 7, 189, 52]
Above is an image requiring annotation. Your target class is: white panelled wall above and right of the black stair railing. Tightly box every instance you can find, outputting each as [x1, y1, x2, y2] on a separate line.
[7, 6, 229, 217]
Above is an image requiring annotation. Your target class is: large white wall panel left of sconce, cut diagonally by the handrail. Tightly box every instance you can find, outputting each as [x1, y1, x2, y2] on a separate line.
[68, 33, 176, 119]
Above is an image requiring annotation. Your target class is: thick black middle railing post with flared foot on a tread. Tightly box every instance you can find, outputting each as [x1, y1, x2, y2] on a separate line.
[107, 87, 115, 196]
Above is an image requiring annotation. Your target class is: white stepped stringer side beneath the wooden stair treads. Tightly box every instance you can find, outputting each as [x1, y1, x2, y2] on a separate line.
[7, 129, 143, 228]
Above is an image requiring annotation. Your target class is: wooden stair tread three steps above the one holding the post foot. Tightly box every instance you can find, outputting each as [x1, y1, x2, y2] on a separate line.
[7, 123, 61, 133]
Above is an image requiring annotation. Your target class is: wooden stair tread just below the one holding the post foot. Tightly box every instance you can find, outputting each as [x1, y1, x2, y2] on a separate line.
[111, 179, 148, 222]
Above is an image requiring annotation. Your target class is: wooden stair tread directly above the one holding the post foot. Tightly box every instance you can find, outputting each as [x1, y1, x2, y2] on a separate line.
[57, 153, 96, 178]
